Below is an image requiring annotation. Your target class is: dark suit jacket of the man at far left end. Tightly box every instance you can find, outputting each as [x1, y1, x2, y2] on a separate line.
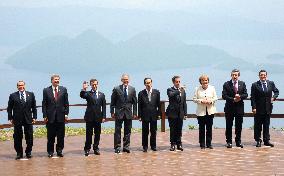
[7, 91, 37, 125]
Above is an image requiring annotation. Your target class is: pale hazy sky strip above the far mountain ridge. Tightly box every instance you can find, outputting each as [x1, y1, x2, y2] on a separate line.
[0, 0, 284, 23]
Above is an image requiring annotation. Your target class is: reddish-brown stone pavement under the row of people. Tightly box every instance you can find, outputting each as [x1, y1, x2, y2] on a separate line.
[0, 129, 284, 176]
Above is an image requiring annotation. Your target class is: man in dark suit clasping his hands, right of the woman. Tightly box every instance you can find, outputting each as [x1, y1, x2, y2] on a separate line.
[222, 69, 248, 148]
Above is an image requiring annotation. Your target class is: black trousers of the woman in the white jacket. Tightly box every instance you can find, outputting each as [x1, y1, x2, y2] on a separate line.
[197, 114, 214, 146]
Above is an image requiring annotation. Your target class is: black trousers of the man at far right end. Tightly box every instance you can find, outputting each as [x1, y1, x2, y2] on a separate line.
[254, 114, 270, 142]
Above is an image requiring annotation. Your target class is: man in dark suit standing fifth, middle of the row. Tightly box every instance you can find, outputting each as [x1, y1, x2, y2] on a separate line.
[138, 78, 161, 152]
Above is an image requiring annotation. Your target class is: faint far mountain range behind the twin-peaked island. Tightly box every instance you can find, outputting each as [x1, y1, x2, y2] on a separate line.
[0, 6, 284, 46]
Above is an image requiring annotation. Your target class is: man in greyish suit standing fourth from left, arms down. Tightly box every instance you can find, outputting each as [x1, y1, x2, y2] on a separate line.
[110, 74, 137, 154]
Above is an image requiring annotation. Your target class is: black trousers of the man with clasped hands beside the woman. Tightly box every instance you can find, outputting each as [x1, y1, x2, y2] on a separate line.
[225, 114, 243, 144]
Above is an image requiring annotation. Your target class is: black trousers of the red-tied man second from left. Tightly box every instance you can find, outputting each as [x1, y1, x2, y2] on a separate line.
[46, 122, 65, 153]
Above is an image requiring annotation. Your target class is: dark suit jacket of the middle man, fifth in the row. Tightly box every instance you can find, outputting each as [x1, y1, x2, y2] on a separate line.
[138, 89, 161, 121]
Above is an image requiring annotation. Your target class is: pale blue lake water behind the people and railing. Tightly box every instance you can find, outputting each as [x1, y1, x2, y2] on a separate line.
[0, 41, 284, 128]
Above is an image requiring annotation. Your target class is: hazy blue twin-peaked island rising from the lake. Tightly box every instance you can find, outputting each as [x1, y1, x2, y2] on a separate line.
[6, 30, 278, 74]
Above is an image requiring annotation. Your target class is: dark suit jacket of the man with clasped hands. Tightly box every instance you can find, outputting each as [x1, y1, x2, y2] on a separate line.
[222, 80, 248, 115]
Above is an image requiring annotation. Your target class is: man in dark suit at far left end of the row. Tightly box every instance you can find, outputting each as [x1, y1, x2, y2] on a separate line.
[7, 81, 37, 160]
